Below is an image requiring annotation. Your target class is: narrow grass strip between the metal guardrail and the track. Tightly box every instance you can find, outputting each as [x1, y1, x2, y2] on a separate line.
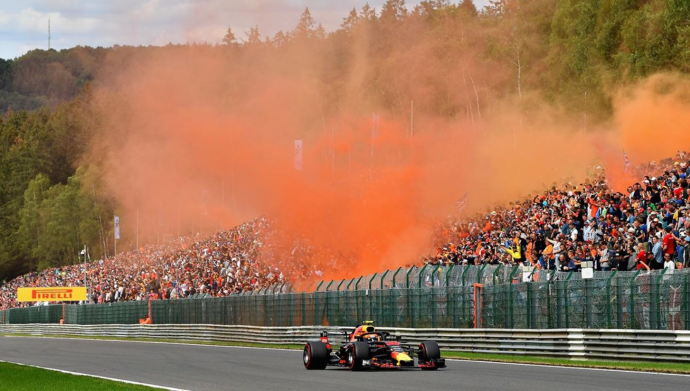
[5, 334, 690, 374]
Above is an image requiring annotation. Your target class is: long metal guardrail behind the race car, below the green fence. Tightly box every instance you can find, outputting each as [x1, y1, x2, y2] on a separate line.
[0, 324, 690, 362]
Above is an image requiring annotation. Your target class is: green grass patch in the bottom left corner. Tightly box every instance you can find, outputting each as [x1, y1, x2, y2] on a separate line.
[0, 362, 159, 391]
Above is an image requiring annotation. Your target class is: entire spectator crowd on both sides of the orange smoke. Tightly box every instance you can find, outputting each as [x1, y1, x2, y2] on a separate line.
[0, 152, 690, 309]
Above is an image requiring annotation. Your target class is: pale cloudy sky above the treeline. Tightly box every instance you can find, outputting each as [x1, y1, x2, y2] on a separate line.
[0, 0, 488, 59]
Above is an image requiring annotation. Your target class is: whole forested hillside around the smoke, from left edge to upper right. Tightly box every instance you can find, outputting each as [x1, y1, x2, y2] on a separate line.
[0, 0, 690, 280]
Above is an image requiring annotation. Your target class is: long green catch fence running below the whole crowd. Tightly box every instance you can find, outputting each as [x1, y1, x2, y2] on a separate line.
[3, 266, 690, 330]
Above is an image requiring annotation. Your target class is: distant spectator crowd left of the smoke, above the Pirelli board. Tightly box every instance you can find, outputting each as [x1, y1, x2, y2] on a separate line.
[0, 218, 286, 309]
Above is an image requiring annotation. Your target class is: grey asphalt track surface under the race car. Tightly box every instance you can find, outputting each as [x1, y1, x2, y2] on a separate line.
[0, 337, 690, 391]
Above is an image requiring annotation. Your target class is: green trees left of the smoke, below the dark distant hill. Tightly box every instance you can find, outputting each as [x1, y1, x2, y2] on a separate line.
[0, 94, 107, 279]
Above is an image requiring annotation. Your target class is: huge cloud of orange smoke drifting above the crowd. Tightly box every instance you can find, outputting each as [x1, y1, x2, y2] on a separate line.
[84, 39, 690, 278]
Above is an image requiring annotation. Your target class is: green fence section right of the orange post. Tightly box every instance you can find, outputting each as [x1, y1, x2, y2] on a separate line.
[482, 270, 690, 330]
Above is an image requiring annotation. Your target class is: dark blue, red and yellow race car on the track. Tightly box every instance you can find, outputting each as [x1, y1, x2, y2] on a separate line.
[302, 321, 446, 371]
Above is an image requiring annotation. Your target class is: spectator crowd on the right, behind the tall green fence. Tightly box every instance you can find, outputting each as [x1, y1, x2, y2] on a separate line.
[430, 152, 690, 271]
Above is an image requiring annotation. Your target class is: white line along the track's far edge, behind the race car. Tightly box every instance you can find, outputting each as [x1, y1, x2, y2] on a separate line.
[5, 335, 690, 377]
